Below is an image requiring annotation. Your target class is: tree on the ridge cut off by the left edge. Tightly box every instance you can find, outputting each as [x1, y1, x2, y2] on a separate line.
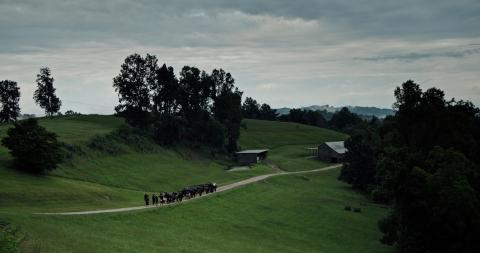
[0, 80, 20, 122]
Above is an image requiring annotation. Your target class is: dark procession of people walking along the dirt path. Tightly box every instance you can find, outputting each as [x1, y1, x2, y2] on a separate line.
[143, 183, 217, 206]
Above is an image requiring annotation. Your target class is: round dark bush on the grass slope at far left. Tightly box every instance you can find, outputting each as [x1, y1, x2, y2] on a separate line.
[2, 118, 62, 174]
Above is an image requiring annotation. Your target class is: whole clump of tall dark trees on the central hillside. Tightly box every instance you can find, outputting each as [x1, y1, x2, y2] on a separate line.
[113, 54, 243, 152]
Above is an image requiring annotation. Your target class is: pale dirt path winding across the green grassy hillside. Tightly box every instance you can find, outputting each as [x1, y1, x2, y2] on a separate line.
[34, 164, 342, 215]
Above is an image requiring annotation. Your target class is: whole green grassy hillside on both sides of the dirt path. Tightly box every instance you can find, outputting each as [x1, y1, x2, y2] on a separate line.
[0, 116, 392, 252]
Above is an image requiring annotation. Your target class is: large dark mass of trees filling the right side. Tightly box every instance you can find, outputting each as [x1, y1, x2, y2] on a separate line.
[340, 80, 480, 253]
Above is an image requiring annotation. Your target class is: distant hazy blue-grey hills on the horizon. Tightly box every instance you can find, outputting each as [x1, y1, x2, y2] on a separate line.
[275, 105, 395, 118]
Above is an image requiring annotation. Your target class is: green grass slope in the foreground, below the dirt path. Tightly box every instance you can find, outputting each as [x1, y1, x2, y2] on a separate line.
[1, 169, 392, 253]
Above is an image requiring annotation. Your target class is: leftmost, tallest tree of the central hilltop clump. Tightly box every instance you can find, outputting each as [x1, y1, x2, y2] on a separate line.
[113, 54, 152, 128]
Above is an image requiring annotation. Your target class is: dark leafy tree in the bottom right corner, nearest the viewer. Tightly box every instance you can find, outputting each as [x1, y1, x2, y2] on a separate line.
[379, 147, 480, 253]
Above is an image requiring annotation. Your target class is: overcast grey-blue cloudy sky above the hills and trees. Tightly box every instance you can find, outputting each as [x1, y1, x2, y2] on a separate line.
[0, 0, 480, 114]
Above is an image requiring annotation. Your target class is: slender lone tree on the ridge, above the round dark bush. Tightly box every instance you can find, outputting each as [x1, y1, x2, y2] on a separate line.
[33, 67, 62, 117]
